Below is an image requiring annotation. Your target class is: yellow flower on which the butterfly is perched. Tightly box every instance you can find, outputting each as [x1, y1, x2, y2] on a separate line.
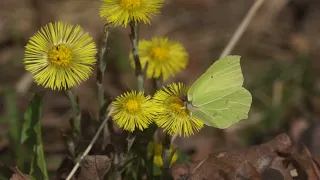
[153, 83, 203, 136]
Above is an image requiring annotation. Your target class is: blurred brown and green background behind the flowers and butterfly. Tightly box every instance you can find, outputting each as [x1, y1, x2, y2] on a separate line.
[0, 0, 320, 179]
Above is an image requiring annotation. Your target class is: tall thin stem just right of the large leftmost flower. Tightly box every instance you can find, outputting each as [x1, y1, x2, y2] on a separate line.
[97, 24, 111, 121]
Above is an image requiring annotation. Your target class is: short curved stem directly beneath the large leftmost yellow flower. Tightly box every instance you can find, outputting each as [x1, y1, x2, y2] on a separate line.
[66, 89, 81, 134]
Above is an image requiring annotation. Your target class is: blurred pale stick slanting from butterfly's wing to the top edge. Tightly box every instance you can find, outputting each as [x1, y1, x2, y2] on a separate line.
[220, 0, 264, 58]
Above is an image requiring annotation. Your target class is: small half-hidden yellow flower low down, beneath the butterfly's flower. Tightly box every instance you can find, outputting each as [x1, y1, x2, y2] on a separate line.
[148, 142, 178, 167]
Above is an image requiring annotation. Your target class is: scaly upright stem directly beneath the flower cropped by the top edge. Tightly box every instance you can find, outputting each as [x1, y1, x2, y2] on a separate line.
[130, 22, 144, 91]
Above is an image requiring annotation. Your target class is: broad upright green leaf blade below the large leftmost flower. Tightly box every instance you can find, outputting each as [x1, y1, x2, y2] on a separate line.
[21, 93, 49, 179]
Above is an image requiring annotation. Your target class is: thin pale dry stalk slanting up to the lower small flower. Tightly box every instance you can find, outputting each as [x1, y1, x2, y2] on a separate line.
[66, 108, 112, 180]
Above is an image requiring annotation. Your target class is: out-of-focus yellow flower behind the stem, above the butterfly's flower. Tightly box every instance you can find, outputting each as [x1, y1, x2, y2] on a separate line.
[131, 37, 188, 80]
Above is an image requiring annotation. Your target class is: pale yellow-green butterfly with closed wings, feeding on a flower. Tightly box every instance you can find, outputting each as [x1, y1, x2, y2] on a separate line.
[185, 55, 252, 129]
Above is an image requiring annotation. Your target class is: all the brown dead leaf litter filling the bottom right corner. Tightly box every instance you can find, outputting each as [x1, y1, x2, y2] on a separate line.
[171, 133, 319, 180]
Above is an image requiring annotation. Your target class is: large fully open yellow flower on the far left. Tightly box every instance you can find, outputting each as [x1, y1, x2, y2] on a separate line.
[23, 21, 97, 90]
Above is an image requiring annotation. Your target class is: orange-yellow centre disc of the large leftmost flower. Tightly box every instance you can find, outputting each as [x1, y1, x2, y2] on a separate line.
[49, 44, 71, 67]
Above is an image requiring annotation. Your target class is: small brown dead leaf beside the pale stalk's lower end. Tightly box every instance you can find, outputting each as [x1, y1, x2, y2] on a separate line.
[77, 155, 111, 180]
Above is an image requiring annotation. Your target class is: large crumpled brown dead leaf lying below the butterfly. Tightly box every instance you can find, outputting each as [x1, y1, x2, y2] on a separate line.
[172, 134, 292, 180]
